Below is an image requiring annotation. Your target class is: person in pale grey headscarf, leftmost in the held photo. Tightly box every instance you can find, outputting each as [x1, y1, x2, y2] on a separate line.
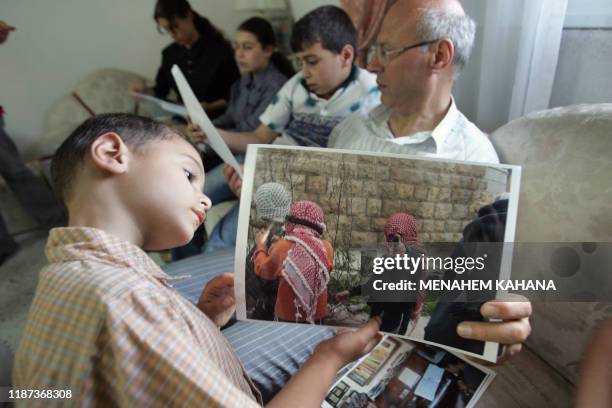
[245, 183, 291, 320]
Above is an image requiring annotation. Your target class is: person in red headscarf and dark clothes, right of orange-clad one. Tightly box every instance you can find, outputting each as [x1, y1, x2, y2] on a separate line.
[335, 213, 426, 334]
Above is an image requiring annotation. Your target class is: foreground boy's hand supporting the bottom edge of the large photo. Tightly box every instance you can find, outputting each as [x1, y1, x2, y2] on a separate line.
[313, 317, 382, 370]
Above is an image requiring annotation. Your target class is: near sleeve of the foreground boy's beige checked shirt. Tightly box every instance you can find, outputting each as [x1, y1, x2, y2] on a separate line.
[100, 292, 259, 407]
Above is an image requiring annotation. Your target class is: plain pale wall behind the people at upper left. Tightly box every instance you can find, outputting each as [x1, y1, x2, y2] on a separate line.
[0, 0, 250, 156]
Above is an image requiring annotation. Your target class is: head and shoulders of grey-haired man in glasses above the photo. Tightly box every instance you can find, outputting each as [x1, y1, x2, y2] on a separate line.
[329, 0, 499, 163]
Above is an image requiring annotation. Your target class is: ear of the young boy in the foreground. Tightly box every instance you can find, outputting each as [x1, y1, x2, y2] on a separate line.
[89, 132, 129, 174]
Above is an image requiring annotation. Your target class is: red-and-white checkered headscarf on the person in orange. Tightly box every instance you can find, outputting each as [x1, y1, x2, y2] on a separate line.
[283, 201, 332, 323]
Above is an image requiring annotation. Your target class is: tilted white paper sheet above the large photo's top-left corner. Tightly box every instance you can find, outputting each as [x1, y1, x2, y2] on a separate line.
[171, 64, 242, 178]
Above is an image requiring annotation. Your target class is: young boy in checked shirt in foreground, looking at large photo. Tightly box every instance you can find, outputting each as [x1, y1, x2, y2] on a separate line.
[13, 114, 380, 407]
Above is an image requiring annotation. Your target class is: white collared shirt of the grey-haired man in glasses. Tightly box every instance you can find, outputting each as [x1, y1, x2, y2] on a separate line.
[328, 98, 499, 163]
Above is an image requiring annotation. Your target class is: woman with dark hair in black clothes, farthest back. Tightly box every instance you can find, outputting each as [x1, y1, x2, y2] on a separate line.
[129, 0, 240, 118]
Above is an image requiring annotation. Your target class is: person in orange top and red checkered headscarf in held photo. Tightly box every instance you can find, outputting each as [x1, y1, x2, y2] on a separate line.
[253, 200, 334, 323]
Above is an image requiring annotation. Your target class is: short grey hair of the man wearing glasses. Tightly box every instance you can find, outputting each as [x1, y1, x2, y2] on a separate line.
[416, 9, 476, 76]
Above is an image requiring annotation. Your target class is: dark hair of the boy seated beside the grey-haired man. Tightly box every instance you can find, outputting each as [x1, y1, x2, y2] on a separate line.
[291, 6, 357, 54]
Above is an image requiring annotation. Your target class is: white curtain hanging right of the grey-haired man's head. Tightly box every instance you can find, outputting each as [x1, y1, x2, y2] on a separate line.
[468, 0, 568, 132]
